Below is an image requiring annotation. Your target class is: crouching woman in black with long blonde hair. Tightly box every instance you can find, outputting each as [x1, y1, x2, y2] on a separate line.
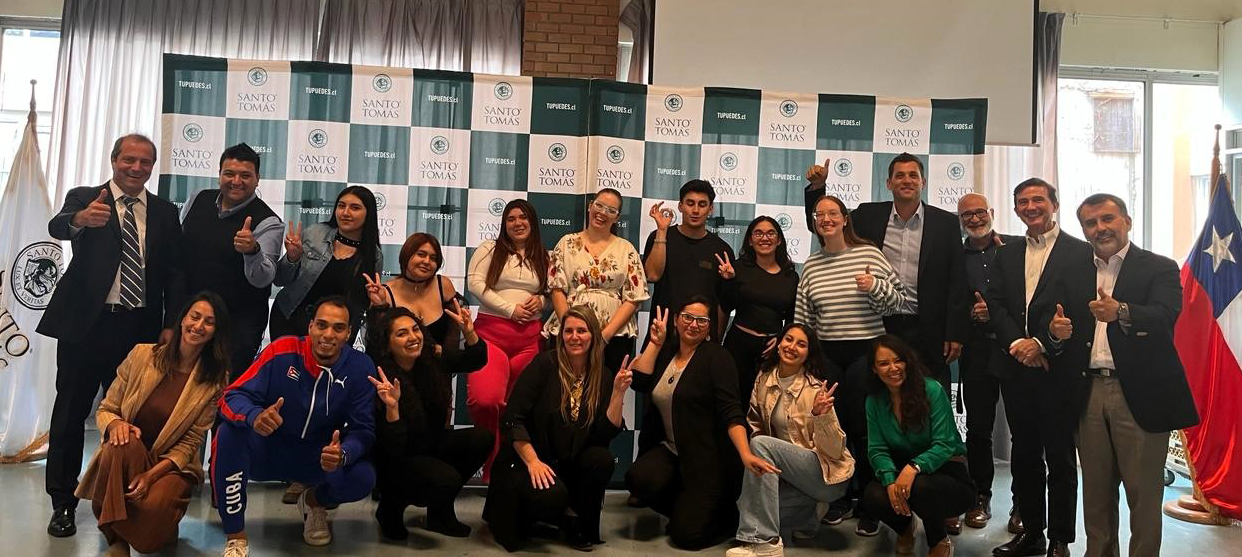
[483, 306, 631, 551]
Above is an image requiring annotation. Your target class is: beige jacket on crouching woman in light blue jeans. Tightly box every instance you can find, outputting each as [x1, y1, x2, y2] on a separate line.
[746, 371, 853, 485]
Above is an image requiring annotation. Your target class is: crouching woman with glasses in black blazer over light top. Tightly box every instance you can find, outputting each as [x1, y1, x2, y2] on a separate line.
[626, 296, 776, 550]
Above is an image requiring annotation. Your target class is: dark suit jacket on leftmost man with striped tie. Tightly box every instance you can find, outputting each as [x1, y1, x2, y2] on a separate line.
[36, 183, 181, 342]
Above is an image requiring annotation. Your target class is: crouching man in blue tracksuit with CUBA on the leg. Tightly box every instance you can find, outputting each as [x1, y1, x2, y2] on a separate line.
[211, 297, 375, 557]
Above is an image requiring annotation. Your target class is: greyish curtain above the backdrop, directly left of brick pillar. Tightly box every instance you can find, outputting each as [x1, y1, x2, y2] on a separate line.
[315, 0, 523, 76]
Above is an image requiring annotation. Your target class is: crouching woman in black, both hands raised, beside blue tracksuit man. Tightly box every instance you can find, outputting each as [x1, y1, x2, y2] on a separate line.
[366, 305, 493, 540]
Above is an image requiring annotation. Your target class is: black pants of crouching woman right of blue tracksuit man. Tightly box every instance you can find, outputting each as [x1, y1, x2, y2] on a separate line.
[375, 428, 493, 518]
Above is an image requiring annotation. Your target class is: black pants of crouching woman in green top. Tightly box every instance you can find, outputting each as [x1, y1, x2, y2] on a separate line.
[863, 460, 973, 547]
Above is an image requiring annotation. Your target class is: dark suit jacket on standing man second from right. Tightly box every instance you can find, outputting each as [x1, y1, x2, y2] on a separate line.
[984, 231, 1095, 408]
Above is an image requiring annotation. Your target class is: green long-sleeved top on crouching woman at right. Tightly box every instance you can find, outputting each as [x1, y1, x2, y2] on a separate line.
[867, 378, 966, 486]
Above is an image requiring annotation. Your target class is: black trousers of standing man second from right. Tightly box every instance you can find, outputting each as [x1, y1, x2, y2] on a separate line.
[1001, 372, 1078, 543]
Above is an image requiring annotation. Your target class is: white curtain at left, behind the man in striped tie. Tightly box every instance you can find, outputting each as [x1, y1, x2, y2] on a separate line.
[47, 0, 319, 206]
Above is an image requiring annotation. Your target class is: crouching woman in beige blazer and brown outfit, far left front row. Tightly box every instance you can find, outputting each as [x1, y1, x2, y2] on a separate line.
[77, 292, 229, 556]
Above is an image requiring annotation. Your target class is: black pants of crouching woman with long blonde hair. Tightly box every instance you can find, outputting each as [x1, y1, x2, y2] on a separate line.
[483, 446, 615, 551]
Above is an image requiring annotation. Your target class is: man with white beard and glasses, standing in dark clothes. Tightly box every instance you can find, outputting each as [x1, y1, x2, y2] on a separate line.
[958, 194, 1022, 533]
